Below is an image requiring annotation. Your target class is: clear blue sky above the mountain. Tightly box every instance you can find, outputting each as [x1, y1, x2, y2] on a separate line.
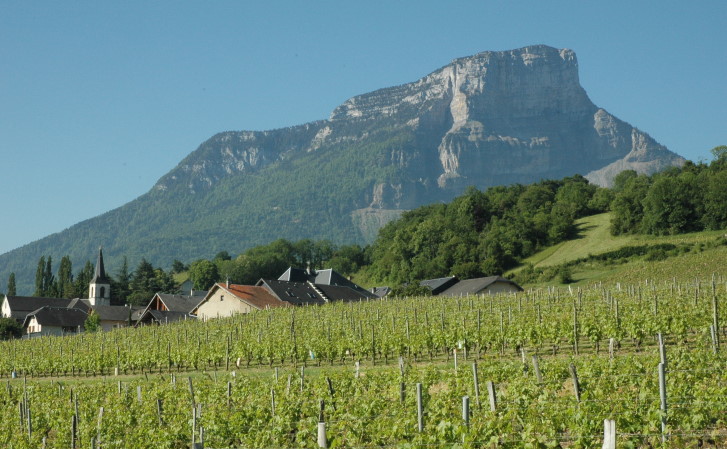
[0, 0, 727, 253]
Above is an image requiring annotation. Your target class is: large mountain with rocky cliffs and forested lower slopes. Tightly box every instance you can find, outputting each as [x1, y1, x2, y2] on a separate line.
[0, 45, 684, 289]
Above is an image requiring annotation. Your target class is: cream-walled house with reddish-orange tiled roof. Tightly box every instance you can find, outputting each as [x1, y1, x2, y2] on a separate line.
[192, 283, 290, 320]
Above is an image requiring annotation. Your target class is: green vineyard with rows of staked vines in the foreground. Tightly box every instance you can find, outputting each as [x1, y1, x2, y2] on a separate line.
[0, 277, 727, 448]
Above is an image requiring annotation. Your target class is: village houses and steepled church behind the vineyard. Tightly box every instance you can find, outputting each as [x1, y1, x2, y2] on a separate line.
[1, 249, 523, 338]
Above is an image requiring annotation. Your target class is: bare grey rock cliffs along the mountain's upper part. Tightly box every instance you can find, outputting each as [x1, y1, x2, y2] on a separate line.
[156, 45, 683, 209]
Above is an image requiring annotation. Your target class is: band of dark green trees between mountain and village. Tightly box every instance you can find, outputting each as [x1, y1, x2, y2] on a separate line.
[8, 146, 727, 305]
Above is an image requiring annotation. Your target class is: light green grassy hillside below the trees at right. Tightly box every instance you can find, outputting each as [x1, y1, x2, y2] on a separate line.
[507, 213, 727, 286]
